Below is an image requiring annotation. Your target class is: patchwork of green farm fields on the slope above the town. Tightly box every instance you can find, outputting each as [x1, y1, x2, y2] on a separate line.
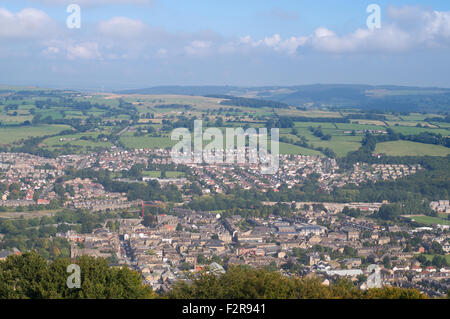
[0, 89, 450, 161]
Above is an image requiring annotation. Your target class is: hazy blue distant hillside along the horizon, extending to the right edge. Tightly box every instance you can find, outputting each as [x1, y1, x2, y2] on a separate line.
[118, 84, 450, 112]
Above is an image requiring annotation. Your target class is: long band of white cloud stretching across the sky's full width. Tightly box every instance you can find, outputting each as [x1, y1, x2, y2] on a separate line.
[0, 4, 450, 60]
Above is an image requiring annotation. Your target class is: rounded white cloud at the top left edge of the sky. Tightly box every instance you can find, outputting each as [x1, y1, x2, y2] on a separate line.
[0, 8, 54, 39]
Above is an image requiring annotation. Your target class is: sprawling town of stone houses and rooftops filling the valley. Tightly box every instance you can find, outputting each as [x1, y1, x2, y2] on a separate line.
[0, 148, 450, 296]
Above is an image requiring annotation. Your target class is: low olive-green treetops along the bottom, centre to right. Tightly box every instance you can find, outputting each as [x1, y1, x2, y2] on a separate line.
[168, 266, 426, 299]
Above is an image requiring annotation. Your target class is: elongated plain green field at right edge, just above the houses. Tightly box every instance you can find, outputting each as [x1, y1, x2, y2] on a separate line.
[375, 141, 450, 156]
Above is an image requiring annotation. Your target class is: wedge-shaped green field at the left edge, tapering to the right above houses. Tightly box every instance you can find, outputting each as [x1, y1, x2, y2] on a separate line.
[0, 125, 70, 144]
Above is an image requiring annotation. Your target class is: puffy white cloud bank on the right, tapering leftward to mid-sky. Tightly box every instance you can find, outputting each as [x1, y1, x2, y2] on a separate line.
[240, 6, 450, 54]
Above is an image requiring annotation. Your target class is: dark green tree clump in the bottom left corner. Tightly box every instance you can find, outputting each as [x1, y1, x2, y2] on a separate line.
[0, 252, 156, 299]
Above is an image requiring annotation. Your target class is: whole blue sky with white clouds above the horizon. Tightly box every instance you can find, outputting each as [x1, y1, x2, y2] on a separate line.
[0, 0, 450, 90]
